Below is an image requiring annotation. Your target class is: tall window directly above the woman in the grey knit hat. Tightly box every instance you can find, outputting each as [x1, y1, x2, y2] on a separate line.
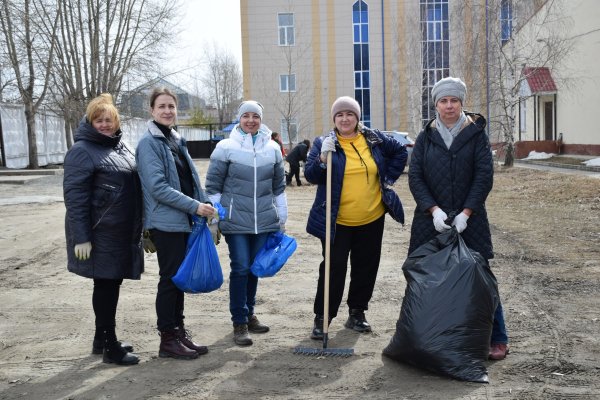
[420, 0, 450, 125]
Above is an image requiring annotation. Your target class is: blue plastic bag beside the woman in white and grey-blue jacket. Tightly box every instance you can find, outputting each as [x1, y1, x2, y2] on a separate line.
[250, 232, 298, 278]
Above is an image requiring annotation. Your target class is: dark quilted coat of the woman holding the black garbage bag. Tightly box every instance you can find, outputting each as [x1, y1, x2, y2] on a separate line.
[408, 112, 494, 259]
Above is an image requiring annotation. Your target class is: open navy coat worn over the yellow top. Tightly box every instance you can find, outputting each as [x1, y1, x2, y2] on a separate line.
[304, 127, 408, 241]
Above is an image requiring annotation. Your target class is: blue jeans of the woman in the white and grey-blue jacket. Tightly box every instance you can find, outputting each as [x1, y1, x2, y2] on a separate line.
[225, 233, 269, 324]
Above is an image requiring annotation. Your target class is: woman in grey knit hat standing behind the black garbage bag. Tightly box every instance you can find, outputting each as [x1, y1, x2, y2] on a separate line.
[408, 77, 508, 360]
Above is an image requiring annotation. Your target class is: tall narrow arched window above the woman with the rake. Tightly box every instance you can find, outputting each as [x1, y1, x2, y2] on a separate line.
[352, 0, 371, 127]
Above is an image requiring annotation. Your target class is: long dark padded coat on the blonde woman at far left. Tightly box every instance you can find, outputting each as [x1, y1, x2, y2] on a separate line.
[63, 119, 144, 279]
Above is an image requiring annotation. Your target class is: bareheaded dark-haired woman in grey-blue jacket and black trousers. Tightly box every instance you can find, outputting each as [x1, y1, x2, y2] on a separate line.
[136, 88, 215, 359]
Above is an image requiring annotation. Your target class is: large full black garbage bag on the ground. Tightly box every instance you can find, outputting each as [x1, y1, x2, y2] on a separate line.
[383, 228, 499, 383]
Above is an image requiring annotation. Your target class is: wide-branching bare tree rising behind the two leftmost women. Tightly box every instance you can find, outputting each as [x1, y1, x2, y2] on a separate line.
[47, 0, 179, 146]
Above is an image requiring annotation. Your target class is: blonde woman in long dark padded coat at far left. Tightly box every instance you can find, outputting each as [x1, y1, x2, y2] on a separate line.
[63, 94, 144, 365]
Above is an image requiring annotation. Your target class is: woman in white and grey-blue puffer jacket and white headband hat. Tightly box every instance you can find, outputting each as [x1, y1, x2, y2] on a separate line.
[206, 100, 287, 346]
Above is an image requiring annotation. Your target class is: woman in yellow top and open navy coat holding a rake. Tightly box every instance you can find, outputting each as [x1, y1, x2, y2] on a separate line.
[304, 96, 408, 340]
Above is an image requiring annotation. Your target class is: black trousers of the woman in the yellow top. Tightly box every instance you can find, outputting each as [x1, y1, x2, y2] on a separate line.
[313, 214, 385, 318]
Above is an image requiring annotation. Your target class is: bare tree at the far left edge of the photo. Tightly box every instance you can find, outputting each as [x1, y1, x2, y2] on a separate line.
[0, 0, 61, 169]
